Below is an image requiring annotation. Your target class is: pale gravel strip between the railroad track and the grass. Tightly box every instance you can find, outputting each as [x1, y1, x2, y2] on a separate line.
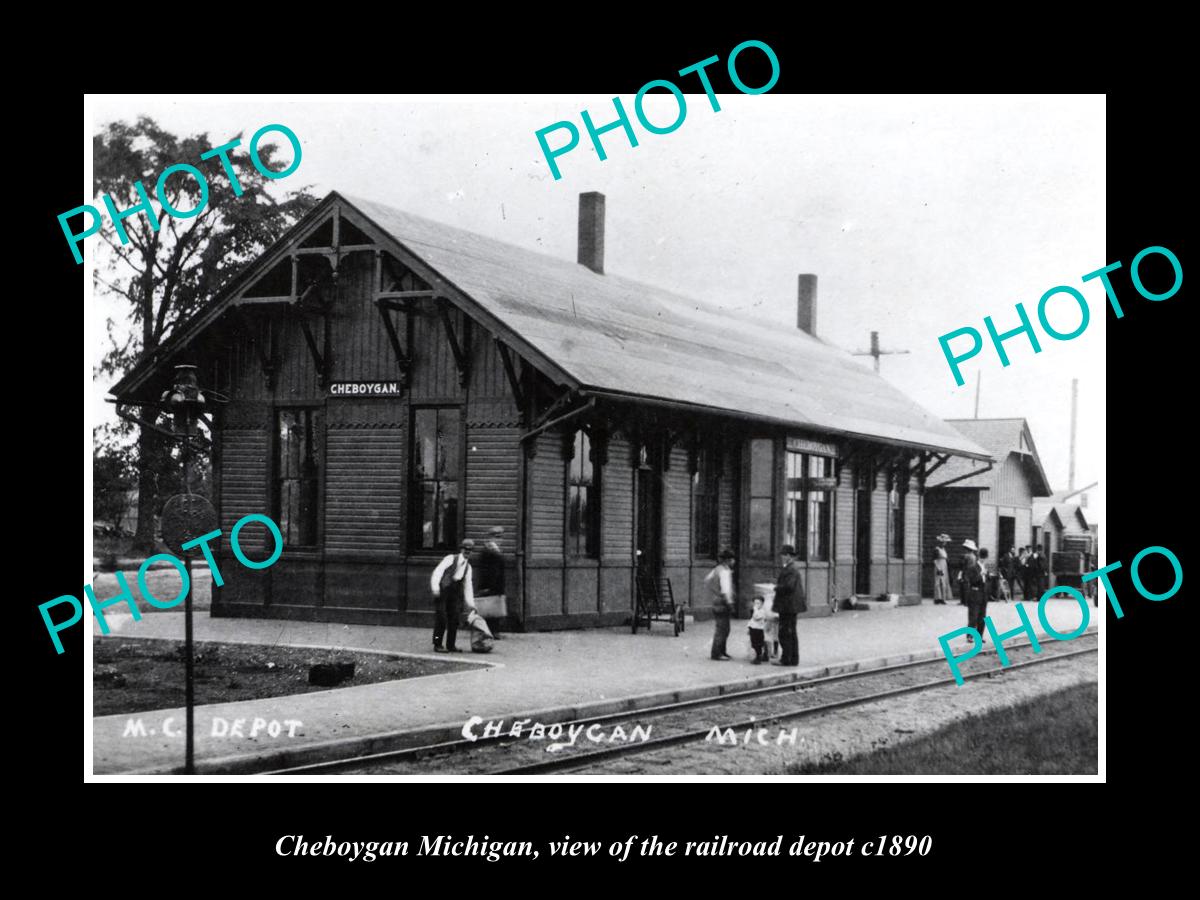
[578, 654, 1097, 775]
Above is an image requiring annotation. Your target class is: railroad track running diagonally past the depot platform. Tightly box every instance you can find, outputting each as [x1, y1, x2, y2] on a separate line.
[270, 631, 1098, 775]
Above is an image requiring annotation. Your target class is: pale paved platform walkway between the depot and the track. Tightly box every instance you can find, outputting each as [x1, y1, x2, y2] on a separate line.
[92, 599, 1103, 774]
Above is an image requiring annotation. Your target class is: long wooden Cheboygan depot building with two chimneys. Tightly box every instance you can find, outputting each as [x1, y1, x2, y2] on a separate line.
[113, 192, 990, 629]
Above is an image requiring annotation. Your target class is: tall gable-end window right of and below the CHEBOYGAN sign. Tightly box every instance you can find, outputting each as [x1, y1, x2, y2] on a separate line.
[408, 407, 462, 551]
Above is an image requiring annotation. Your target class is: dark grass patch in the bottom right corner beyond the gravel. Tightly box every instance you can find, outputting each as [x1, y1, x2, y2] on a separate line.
[787, 683, 1099, 775]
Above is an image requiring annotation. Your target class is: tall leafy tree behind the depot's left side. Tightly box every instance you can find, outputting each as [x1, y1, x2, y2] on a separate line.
[92, 116, 317, 552]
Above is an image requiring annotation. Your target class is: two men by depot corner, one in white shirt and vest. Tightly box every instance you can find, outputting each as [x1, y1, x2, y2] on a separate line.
[430, 526, 506, 653]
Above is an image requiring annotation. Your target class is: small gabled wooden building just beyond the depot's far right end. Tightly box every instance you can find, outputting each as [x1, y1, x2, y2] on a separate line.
[922, 419, 1050, 596]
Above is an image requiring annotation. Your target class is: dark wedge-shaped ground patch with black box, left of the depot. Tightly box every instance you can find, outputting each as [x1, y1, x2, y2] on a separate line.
[91, 637, 473, 715]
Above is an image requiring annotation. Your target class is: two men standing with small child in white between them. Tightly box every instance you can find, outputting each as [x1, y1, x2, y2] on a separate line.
[704, 544, 809, 666]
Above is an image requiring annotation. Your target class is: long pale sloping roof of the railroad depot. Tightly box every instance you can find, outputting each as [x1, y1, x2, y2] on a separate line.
[114, 193, 989, 460]
